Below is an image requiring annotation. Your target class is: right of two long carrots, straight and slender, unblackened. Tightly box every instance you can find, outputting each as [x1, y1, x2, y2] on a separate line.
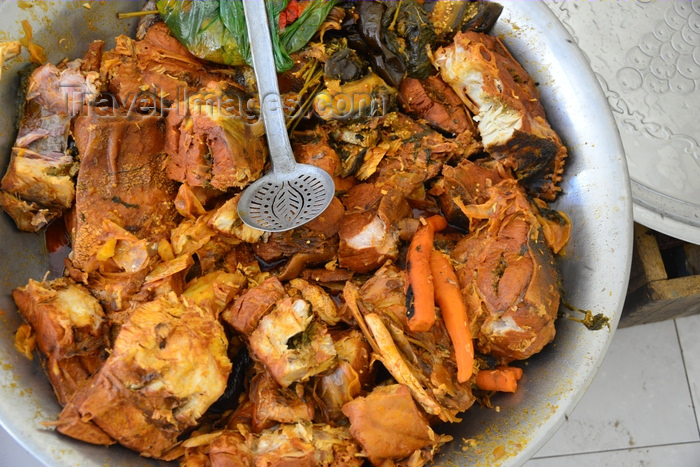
[430, 250, 474, 383]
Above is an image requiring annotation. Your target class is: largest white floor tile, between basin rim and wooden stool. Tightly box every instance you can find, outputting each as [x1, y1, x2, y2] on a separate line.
[535, 321, 700, 458]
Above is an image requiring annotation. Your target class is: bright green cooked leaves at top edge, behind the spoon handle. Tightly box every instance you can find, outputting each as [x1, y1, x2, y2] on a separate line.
[156, 0, 337, 72]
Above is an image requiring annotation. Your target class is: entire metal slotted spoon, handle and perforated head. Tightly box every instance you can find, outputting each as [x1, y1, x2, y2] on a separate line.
[238, 1, 335, 232]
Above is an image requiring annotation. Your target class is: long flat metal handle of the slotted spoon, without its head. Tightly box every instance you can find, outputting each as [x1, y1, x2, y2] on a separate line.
[243, 0, 296, 172]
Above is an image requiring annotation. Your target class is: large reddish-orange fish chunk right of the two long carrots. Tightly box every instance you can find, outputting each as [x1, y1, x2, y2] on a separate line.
[452, 179, 560, 361]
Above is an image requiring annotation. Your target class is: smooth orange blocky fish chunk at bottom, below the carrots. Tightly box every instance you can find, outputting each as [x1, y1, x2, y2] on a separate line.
[343, 384, 445, 465]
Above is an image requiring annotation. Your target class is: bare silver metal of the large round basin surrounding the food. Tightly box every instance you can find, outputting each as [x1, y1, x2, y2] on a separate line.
[0, 1, 632, 467]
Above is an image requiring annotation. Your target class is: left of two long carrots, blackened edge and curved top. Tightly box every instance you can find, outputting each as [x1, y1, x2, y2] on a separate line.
[406, 216, 447, 332]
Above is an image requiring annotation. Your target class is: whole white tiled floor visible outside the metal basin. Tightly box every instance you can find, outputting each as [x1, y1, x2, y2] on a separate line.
[0, 315, 700, 467]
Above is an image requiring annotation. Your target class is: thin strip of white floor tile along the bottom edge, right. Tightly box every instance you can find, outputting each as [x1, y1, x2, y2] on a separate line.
[523, 443, 700, 467]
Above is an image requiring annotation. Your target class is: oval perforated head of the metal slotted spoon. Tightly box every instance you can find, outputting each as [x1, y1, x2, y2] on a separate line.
[238, 164, 335, 232]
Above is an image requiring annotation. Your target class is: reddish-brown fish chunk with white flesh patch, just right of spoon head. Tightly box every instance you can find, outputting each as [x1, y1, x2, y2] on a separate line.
[338, 183, 411, 272]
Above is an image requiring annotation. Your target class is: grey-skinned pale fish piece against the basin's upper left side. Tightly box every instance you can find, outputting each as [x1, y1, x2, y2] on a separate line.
[0, 60, 100, 232]
